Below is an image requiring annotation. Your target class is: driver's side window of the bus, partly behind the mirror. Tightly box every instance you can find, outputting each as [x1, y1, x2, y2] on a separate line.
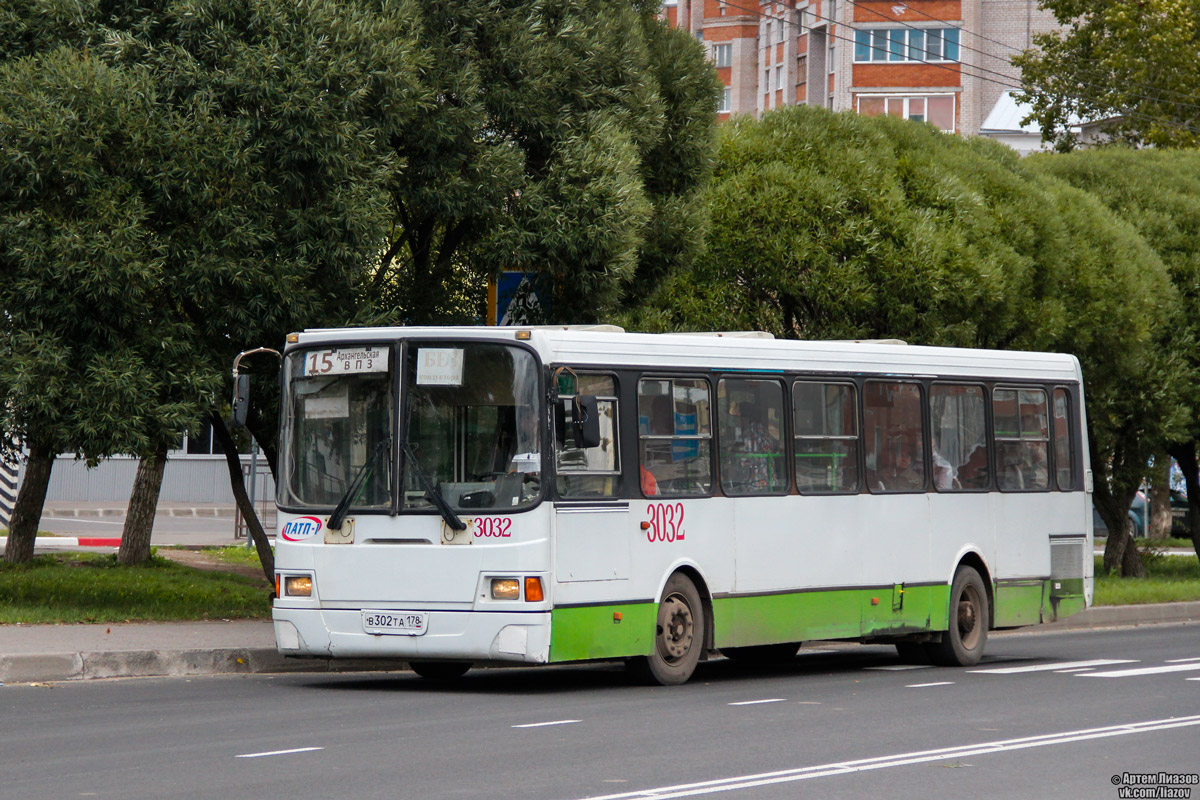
[554, 373, 620, 498]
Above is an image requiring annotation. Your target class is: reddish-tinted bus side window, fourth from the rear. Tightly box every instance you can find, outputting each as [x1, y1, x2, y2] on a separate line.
[863, 380, 925, 492]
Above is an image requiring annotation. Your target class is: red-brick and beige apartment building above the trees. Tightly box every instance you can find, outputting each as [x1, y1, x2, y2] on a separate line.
[664, 0, 1056, 136]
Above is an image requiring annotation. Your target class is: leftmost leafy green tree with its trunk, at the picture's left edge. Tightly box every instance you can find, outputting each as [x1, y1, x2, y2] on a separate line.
[0, 48, 210, 561]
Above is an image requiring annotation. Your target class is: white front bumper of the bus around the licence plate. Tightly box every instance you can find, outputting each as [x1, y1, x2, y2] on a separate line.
[271, 607, 550, 663]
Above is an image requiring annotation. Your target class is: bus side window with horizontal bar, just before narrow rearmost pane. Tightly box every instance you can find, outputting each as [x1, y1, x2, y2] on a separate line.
[991, 389, 1050, 492]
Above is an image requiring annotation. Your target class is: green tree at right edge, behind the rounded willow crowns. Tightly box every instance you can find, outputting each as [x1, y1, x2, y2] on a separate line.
[1030, 148, 1200, 557]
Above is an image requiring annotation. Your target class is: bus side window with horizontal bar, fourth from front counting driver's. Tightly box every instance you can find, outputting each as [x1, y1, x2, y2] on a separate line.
[792, 380, 858, 494]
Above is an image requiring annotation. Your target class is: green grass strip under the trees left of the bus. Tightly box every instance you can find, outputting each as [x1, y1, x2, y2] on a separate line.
[0, 553, 271, 624]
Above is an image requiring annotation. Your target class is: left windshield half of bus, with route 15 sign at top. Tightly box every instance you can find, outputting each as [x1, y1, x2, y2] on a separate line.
[278, 345, 395, 510]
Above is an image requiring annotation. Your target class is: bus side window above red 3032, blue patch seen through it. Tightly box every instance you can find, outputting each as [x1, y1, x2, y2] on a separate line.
[637, 378, 713, 497]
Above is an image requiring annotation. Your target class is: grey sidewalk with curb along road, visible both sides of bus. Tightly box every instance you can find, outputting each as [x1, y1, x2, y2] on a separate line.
[0, 601, 1200, 684]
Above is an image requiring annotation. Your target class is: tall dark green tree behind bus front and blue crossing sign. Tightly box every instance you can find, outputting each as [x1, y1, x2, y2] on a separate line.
[371, 0, 718, 323]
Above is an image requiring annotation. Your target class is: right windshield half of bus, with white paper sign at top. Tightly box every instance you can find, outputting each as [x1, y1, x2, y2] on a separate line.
[401, 342, 542, 511]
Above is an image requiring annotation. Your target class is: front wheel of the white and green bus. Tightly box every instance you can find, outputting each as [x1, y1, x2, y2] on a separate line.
[629, 572, 706, 686]
